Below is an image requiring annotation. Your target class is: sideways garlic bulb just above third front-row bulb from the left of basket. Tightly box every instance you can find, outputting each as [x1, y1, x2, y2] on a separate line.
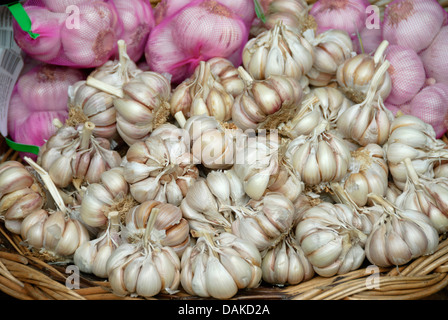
[232, 192, 296, 254]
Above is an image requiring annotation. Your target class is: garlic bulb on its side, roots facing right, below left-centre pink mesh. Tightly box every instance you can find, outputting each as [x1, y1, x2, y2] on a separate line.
[114, 71, 171, 146]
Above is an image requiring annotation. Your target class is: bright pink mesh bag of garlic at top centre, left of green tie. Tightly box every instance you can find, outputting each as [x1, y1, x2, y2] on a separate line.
[145, 0, 248, 83]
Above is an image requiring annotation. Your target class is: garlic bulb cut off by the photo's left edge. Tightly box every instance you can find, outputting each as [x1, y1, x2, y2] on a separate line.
[0, 160, 46, 234]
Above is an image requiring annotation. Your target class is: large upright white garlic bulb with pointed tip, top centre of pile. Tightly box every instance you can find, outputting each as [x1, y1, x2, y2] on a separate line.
[243, 21, 315, 80]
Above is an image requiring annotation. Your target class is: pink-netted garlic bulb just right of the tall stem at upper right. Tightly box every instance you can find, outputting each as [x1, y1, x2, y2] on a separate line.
[386, 45, 426, 105]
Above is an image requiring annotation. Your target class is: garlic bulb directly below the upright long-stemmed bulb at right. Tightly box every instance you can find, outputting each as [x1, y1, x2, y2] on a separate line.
[341, 144, 389, 207]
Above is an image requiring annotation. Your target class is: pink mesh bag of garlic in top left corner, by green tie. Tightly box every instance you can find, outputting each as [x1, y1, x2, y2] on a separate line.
[13, 0, 122, 68]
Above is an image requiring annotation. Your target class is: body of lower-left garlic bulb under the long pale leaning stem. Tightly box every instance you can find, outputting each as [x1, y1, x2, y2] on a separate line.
[20, 209, 90, 258]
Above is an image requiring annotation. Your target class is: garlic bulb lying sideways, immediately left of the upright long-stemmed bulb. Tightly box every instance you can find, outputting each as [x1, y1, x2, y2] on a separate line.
[278, 87, 353, 139]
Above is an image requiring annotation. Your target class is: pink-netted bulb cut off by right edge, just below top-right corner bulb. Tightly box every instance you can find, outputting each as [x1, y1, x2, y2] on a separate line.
[420, 26, 448, 84]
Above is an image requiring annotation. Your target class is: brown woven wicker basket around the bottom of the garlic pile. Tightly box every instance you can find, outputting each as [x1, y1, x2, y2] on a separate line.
[0, 0, 448, 300]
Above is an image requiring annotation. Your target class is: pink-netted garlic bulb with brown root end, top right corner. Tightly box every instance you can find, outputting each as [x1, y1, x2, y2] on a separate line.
[383, 0, 446, 52]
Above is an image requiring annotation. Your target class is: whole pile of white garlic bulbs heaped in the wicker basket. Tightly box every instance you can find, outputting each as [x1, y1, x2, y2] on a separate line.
[5, 9, 448, 299]
